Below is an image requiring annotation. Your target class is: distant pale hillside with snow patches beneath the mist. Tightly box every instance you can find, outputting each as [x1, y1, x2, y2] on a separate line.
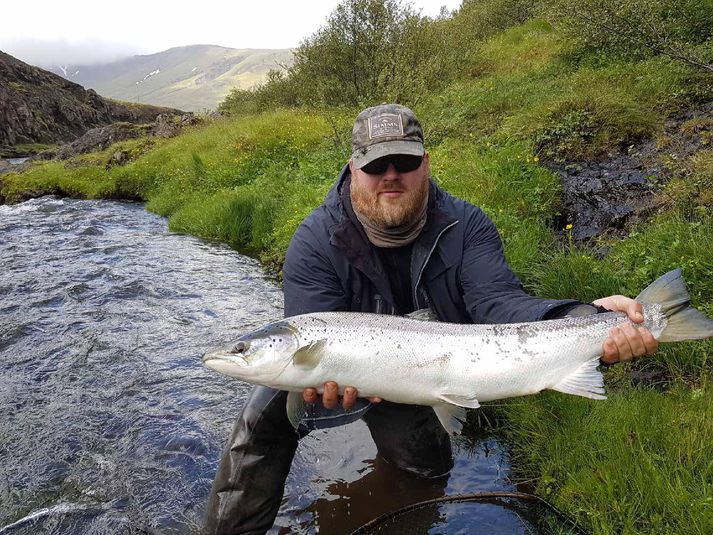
[48, 45, 292, 111]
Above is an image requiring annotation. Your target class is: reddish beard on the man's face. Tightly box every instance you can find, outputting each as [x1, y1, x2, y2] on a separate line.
[350, 176, 428, 228]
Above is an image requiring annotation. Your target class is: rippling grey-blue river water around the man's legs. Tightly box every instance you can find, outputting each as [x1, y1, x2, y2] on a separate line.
[0, 197, 568, 535]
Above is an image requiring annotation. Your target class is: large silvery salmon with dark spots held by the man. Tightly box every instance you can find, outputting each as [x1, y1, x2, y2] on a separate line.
[203, 269, 713, 433]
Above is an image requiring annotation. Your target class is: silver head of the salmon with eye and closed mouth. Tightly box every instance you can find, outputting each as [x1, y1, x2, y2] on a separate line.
[203, 320, 299, 385]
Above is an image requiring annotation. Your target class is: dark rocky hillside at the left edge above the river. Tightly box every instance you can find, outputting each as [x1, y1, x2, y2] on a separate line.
[0, 51, 177, 152]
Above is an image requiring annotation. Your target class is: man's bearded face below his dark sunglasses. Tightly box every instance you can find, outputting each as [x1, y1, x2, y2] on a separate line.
[349, 153, 430, 228]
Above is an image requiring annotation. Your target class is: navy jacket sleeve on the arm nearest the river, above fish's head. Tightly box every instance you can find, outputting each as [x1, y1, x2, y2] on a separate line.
[282, 224, 349, 317]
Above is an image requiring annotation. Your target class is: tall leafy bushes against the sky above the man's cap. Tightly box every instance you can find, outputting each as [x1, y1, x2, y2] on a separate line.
[219, 0, 544, 115]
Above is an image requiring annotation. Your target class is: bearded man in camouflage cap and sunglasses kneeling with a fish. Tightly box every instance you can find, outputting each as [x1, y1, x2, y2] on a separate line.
[206, 104, 657, 533]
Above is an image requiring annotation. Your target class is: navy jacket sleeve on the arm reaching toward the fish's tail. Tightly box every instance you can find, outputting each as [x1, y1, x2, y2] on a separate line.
[461, 208, 578, 323]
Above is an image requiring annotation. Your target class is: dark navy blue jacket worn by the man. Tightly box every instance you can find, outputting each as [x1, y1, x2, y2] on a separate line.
[283, 166, 578, 323]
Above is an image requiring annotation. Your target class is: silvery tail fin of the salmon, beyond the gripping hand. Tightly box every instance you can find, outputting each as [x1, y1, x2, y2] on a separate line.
[636, 269, 713, 342]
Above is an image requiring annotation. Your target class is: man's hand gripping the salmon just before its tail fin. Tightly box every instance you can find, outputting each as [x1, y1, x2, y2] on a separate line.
[592, 295, 659, 364]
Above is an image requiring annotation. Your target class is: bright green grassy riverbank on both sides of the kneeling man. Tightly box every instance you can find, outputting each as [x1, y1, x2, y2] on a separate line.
[0, 6, 713, 534]
